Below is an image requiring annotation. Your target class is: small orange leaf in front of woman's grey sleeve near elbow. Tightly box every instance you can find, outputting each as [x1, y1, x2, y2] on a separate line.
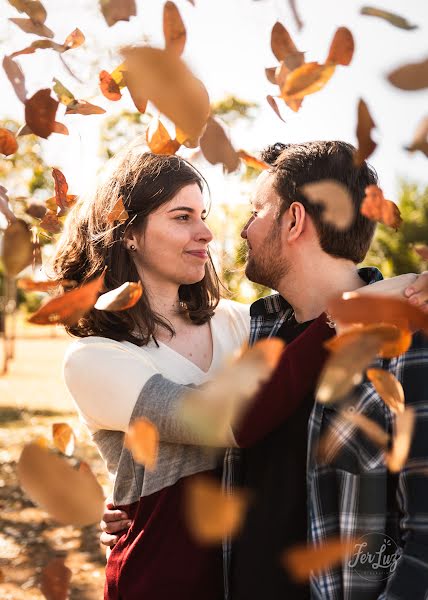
[124, 418, 159, 471]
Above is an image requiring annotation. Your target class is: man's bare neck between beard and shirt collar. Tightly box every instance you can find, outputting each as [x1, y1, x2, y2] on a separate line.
[278, 257, 365, 323]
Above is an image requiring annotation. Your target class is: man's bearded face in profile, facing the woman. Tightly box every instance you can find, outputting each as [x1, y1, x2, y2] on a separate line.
[241, 171, 288, 289]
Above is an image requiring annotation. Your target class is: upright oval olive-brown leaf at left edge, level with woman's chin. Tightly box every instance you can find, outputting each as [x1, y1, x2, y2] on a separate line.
[2, 219, 33, 277]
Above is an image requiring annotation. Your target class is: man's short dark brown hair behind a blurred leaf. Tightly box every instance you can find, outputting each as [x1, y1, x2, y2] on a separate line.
[262, 141, 378, 264]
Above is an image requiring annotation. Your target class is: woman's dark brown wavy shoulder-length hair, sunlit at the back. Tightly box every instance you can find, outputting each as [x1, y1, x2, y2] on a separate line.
[53, 142, 220, 346]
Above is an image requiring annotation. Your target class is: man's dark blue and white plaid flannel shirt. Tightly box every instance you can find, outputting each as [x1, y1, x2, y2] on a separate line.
[223, 268, 428, 600]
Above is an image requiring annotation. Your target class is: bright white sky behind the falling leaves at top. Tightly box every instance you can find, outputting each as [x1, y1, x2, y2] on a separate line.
[0, 0, 428, 206]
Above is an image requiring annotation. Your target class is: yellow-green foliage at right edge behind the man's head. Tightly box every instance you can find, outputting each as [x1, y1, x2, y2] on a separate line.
[364, 182, 428, 277]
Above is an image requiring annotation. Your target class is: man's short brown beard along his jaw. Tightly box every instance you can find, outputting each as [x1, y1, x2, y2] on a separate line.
[245, 224, 289, 290]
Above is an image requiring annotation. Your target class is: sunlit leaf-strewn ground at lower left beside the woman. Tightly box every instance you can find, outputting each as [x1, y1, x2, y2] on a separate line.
[0, 318, 109, 600]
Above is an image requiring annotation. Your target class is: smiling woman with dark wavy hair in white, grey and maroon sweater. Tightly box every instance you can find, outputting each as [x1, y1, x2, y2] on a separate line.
[55, 146, 428, 600]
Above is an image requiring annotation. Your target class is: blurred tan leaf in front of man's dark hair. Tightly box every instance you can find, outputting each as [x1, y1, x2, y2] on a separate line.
[301, 179, 354, 229]
